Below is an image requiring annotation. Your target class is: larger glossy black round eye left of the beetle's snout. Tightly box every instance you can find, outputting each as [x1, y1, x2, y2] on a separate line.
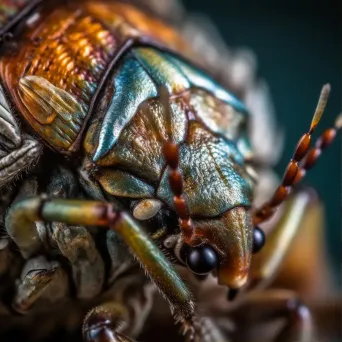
[181, 246, 219, 274]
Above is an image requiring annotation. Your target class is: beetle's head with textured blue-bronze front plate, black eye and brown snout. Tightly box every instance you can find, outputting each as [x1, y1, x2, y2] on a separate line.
[157, 121, 260, 289]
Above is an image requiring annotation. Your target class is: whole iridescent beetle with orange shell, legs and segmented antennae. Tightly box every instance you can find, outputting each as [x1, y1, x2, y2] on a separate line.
[0, 1, 341, 341]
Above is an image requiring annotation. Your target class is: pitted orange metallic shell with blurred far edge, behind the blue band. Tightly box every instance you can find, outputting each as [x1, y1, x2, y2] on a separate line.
[0, 1, 188, 154]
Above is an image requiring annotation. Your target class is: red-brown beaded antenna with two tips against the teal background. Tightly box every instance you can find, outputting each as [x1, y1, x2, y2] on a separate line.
[253, 84, 342, 225]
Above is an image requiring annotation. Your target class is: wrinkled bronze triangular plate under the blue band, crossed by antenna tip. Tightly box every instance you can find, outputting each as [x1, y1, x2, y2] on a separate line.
[88, 98, 186, 182]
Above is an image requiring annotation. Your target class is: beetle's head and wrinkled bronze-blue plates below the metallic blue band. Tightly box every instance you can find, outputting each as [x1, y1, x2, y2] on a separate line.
[85, 84, 262, 288]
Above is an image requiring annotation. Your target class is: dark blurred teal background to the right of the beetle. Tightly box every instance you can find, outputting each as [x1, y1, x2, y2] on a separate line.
[183, 0, 342, 284]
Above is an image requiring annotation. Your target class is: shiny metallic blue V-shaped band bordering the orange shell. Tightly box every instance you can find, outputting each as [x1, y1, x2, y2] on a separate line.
[93, 47, 247, 162]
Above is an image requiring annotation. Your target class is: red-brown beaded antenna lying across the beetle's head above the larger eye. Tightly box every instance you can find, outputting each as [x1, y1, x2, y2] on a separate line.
[159, 87, 194, 243]
